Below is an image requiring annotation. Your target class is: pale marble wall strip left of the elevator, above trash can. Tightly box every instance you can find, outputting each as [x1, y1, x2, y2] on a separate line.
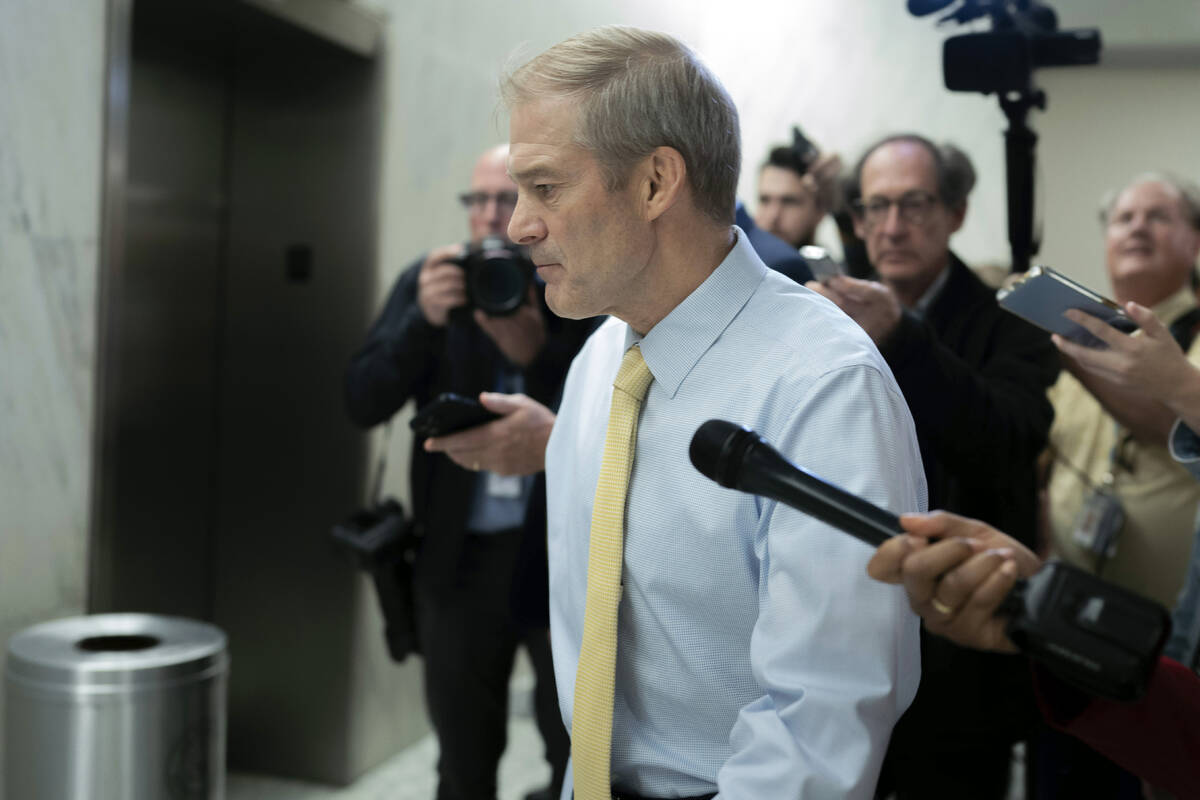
[0, 0, 104, 786]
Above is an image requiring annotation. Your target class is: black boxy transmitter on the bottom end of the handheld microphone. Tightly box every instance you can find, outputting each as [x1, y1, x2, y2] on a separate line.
[1001, 561, 1171, 700]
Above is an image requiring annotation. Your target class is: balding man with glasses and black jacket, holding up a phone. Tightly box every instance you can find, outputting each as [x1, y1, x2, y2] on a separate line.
[808, 134, 1058, 800]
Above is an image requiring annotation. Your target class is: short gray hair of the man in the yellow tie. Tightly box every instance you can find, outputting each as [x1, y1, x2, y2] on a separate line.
[500, 25, 742, 224]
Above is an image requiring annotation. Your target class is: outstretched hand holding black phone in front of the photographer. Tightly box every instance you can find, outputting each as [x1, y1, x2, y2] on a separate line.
[425, 392, 554, 475]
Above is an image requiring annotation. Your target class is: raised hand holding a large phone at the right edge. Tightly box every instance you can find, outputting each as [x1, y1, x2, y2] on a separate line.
[1051, 302, 1200, 415]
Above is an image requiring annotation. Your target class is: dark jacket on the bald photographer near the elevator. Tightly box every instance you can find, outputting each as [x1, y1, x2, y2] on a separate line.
[346, 257, 598, 615]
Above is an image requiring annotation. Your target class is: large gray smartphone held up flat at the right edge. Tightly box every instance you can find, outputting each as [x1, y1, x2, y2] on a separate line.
[996, 265, 1138, 349]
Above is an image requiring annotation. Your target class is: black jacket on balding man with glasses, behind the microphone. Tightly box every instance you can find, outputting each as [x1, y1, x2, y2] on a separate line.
[880, 254, 1058, 751]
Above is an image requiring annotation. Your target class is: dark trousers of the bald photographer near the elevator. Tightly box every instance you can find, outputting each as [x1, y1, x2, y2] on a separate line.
[416, 530, 570, 800]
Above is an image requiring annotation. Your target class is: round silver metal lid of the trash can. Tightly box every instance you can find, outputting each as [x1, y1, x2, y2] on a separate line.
[6, 614, 229, 691]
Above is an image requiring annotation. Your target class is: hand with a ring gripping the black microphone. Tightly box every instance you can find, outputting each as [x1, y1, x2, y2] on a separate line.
[868, 511, 1040, 652]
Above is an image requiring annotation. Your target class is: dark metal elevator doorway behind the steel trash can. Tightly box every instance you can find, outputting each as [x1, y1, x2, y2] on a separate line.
[90, 0, 420, 782]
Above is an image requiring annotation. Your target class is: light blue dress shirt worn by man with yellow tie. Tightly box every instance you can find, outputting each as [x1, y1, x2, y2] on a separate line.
[546, 231, 925, 800]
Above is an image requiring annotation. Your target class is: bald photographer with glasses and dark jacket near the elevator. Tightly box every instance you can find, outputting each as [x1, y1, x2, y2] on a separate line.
[347, 145, 594, 800]
